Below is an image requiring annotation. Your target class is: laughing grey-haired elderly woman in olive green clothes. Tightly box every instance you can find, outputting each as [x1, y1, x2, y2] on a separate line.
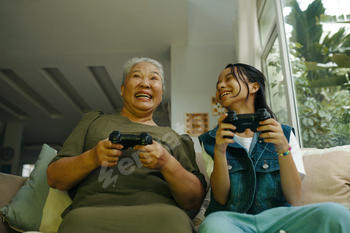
[47, 58, 206, 233]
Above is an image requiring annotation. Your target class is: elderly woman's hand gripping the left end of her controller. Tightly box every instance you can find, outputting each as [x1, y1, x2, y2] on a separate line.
[91, 139, 123, 167]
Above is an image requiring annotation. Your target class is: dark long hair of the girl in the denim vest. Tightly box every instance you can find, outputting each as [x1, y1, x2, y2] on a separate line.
[225, 63, 277, 120]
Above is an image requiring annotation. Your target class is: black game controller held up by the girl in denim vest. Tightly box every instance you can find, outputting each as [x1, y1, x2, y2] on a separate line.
[223, 108, 271, 133]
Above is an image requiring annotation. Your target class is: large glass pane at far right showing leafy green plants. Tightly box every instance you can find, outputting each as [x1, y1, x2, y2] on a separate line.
[283, 0, 350, 148]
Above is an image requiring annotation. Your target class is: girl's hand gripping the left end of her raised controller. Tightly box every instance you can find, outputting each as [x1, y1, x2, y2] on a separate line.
[215, 113, 236, 152]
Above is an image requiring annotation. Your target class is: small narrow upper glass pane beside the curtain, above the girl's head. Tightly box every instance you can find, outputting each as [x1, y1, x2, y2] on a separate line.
[259, 0, 276, 45]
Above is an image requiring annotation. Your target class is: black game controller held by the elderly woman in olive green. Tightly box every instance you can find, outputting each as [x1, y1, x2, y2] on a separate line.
[109, 131, 152, 150]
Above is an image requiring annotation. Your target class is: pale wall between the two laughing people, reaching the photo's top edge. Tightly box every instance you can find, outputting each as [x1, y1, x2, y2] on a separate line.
[170, 0, 238, 151]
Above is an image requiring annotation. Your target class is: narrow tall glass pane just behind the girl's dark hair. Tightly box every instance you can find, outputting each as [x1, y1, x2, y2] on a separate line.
[265, 37, 288, 124]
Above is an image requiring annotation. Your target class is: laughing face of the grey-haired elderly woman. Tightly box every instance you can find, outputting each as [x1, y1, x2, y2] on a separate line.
[121, 62, 163, 114]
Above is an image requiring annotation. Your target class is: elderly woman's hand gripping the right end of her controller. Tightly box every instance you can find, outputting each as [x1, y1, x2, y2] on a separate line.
[134, 141, 171, 170]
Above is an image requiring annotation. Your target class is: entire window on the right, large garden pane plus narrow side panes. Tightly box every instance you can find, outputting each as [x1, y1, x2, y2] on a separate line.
[259, 0, 350, 148]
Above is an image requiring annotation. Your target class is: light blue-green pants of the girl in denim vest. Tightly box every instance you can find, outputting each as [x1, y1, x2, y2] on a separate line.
[199, 202, 350, 233]
